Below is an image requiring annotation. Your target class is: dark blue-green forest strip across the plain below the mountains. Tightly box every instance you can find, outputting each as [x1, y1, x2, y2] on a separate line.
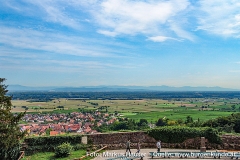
[10, 91, 240, 101]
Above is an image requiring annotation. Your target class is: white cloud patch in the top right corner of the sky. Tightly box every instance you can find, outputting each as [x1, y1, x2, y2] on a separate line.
[198, 0, 240, 38]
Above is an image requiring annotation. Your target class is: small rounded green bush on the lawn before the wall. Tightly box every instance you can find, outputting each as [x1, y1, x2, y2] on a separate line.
[55, 143, 73, 157]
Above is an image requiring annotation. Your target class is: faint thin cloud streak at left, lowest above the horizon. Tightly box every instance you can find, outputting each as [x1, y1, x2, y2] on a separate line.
[0, 55, 137, 73]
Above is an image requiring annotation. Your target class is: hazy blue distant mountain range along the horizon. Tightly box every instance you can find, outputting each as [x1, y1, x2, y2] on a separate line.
[8, 85, 240, 92]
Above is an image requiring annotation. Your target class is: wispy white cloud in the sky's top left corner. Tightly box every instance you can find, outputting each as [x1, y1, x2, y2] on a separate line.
[4, 0, 81, 29]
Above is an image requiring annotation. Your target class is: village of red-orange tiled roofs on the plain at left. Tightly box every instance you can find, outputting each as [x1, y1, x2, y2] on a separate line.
[20, 112, 117, 136]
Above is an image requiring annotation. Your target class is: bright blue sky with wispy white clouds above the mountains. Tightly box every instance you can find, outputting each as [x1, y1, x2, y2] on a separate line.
[0, 0, 240, 89]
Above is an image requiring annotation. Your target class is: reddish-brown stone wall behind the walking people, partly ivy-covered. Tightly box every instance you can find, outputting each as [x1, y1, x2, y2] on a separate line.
[88, 132, 240, 150]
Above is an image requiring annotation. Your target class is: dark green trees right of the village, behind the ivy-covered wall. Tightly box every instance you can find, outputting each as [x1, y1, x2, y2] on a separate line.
[94, 113, 240, 133]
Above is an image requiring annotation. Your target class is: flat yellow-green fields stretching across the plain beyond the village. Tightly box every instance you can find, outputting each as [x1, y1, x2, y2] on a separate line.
[12, 98, 240, 122]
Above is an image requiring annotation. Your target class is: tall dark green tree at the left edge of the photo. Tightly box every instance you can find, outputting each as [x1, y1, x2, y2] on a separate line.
[0, 78, 25, 160]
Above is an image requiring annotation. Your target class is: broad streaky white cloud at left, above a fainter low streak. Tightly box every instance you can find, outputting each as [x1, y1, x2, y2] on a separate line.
[0, 26, 114, 57]
